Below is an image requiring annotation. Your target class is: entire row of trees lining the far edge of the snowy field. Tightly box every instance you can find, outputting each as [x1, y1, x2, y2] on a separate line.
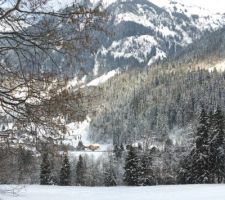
[0, 107, 225, 186]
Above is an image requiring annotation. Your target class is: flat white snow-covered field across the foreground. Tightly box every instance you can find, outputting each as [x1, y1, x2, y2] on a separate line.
[0, 185, 225, 200]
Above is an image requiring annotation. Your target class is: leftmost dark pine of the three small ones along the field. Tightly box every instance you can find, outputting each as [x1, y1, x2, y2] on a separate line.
[40, 153, 52, 185]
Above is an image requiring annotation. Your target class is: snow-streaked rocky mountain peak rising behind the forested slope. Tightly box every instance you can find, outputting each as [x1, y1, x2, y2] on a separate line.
[29, 0, 225, 80]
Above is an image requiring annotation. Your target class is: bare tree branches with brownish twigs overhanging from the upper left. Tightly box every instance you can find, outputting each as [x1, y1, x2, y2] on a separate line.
[0, 0, 105, 144]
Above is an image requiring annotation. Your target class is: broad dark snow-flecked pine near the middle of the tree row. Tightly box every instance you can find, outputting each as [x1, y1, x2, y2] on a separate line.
[124, 146, 142, 186]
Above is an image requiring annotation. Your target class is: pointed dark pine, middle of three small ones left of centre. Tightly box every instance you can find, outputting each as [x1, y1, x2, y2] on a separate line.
[59, 154, 71, 186]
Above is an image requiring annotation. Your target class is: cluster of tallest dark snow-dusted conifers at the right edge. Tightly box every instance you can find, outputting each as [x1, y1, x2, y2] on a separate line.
[178, 108, 225, 184]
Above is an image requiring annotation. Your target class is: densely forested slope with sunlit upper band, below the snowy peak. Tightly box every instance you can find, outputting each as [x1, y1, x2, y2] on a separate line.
[86, 29, 225, 143]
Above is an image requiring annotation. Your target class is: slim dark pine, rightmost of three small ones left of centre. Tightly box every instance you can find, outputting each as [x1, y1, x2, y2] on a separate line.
[76, 155, 86, 186]
